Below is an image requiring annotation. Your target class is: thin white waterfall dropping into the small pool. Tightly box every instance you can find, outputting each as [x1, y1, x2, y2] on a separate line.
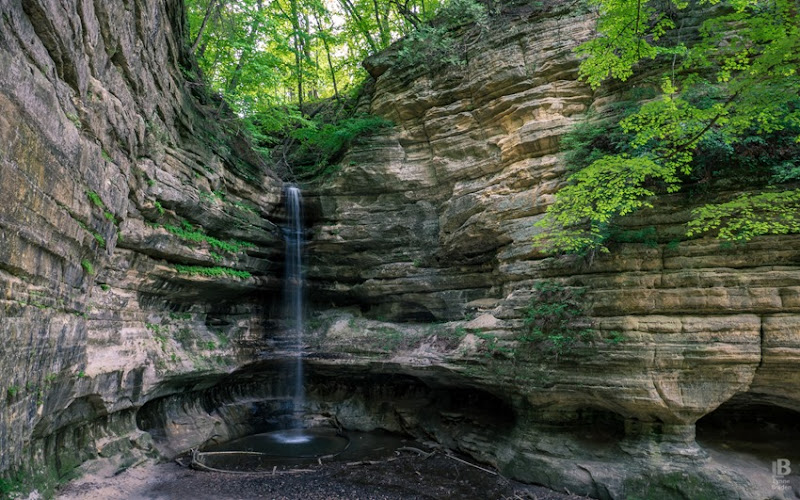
[284, 186, 305, 420]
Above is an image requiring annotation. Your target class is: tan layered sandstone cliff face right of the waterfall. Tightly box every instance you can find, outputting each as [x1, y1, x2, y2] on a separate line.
[298, 1, 800, 497]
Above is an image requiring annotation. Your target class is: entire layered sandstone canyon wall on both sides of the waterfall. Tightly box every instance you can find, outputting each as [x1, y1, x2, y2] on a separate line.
[0, 0, 800, 498]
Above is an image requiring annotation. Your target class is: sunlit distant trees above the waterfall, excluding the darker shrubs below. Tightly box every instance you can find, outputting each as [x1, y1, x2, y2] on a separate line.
[186, 0, 456, 114]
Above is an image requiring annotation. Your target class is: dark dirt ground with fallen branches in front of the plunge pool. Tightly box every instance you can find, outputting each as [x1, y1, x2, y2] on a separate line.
[56, 452, 586, 500]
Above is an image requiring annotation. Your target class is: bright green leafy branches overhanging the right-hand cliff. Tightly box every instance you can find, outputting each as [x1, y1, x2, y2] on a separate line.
[535, 0, 800, 253]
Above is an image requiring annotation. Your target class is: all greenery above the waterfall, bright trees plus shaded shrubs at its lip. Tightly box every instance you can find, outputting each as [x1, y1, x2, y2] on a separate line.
[185, 0, 487, 179]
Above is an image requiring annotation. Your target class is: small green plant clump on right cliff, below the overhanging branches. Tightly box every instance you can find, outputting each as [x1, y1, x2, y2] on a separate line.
[518, 281, 608, 359]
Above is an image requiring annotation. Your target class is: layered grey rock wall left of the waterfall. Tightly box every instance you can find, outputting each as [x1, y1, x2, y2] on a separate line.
[0, 0, 282, 484]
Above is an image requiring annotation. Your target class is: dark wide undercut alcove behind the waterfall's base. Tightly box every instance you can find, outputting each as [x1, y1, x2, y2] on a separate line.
[136, 359, 517, 458]
